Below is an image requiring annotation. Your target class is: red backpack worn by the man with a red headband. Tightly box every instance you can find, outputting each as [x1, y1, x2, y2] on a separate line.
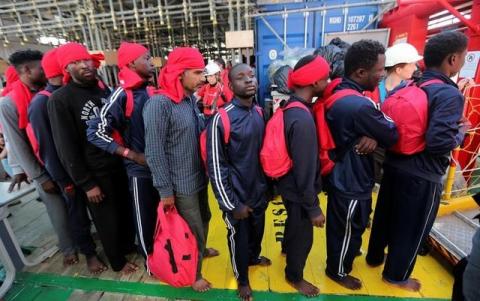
[260, 101, 310, 179]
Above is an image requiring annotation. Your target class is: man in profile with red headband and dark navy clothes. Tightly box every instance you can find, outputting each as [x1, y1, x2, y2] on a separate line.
[278, 55, 330, 297]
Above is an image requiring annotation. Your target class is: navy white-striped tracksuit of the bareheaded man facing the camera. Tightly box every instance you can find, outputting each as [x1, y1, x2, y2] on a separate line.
[207, 99, 267, 285]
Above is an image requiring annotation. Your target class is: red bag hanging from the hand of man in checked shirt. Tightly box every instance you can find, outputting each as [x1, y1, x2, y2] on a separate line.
[147, 202, 198, 287]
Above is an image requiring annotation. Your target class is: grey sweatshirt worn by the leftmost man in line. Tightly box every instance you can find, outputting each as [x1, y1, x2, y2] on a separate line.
[0, 96, 50, 184]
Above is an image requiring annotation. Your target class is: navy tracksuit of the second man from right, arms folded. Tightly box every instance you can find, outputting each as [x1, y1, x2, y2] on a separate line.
[326, 78, 398, 279]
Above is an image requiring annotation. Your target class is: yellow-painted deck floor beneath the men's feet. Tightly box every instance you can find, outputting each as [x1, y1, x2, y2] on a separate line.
[203, 191, 453, 299]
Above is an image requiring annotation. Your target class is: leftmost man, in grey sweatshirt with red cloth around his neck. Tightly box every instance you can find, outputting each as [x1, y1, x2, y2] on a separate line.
[0, 50, 77, 265]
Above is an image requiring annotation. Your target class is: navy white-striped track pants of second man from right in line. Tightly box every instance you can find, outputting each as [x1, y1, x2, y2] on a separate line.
[326, 189, 372, 280]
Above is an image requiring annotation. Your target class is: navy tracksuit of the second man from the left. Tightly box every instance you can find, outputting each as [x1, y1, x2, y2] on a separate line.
[28, 84, 96, 257]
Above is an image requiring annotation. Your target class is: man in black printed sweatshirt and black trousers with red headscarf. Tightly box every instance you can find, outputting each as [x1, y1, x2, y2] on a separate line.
[47, 43, 138, 274]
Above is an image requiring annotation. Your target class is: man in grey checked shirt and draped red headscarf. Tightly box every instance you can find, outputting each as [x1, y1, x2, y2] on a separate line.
[143, 47, 218, 291]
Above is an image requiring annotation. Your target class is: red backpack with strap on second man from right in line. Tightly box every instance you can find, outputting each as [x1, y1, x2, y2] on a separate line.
[313, 78, 363, 176]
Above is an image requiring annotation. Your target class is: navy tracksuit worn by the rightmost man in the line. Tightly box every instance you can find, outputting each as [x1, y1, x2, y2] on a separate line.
[367, 70, 465, 282]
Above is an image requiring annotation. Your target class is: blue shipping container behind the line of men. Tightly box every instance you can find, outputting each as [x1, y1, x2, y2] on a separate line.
[255, 0, 388, 105]
